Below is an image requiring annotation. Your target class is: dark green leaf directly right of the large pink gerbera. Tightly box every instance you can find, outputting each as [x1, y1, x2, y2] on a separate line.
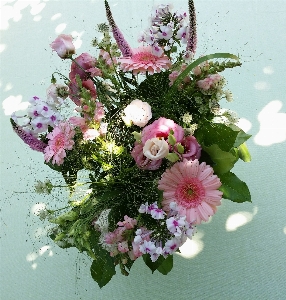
[219, 172, 251, 203]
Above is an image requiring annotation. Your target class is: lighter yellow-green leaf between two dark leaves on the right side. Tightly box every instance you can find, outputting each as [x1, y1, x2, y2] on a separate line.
[203, 144, 238, 174]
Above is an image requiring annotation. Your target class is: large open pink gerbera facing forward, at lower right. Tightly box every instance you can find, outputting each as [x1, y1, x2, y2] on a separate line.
[158, 159, 223, 224]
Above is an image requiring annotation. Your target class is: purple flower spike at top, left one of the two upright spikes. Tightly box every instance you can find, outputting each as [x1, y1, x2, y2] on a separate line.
[104, 0, 132, 57]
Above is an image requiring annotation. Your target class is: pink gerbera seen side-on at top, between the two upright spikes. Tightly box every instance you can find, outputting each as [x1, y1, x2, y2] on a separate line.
[118, 46, 171, 74]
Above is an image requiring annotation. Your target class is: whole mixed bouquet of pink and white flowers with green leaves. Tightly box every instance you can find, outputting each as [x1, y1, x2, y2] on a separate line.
[11, 0, 251, 287]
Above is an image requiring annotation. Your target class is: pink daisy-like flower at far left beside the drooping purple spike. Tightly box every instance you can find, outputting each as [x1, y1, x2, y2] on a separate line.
[44, 122, 75, 165]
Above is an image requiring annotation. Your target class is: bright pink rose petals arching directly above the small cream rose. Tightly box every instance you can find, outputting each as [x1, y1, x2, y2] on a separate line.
[141, 117, 184, 144]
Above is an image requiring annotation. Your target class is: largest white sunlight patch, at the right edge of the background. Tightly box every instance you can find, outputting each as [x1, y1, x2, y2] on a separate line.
[254, 100, 286, 146]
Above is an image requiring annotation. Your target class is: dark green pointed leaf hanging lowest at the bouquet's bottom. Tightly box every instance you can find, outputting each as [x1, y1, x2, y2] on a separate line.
[90, 251, 116, 288]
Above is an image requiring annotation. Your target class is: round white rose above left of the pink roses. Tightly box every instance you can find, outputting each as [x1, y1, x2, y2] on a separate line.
[123, 99, 152, 127]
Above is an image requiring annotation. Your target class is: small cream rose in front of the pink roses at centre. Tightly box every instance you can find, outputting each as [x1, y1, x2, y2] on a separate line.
[143, 138, 169, 160]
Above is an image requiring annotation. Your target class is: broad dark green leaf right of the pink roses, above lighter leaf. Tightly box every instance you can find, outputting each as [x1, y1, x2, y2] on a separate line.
[195, 122, 239, 152]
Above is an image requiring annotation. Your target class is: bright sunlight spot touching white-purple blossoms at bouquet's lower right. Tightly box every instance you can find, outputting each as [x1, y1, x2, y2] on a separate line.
[176, 231, 204, 258]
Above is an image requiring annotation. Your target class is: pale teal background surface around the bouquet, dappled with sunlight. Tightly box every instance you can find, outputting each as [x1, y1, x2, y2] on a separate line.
[0, 0, 286, 300]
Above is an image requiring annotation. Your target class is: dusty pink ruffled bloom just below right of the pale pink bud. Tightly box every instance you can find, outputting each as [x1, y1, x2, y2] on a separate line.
[69, 53, 99, 81]
